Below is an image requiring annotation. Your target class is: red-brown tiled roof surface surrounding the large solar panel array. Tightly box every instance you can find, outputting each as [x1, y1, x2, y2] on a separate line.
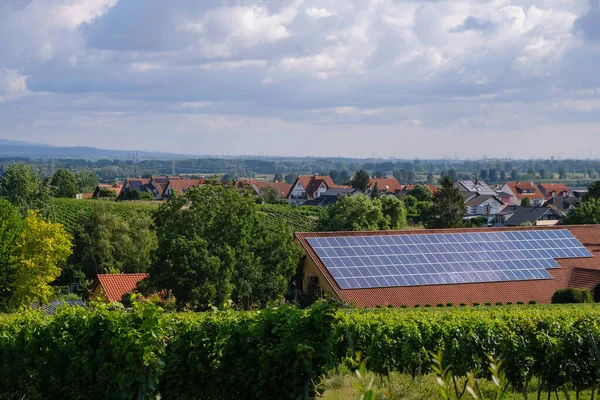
[295, 225, 600, 307]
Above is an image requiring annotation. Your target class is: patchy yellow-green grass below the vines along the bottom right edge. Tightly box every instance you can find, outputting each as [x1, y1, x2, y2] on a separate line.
[317, 371, 598, 400]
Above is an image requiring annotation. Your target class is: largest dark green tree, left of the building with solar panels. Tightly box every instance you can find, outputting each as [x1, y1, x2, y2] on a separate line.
[147, 185, 301, 310]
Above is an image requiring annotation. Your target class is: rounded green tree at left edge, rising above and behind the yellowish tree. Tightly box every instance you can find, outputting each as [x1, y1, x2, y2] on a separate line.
[0, 163, 48, 214]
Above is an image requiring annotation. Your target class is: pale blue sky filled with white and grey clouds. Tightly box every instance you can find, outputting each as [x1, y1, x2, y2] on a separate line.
[0, 0, 600, 158]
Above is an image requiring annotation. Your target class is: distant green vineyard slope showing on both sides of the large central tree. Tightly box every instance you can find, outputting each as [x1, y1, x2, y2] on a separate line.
[47, 199, 324, 233]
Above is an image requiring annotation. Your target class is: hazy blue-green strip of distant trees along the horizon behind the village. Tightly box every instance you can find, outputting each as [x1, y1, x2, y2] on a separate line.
[0, 157, 600, 185]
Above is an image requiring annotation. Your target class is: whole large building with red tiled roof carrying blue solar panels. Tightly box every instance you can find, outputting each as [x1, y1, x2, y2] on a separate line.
[295, 225, 600, 307]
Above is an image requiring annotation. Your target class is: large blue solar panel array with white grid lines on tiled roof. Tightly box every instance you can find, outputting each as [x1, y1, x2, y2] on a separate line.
[307, 229, 592, 289]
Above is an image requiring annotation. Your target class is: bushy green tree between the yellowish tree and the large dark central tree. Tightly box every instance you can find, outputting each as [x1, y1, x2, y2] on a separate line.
[73, 204, 157, 278]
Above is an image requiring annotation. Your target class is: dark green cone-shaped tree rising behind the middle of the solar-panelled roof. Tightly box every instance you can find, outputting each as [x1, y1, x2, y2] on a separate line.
[425, 176, 465, 228]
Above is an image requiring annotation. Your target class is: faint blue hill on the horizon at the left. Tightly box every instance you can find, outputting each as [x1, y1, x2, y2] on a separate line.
[0, 139, 183, 159]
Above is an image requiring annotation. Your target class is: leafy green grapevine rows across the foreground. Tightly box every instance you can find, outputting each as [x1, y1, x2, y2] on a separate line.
[0, 303, 600, 399]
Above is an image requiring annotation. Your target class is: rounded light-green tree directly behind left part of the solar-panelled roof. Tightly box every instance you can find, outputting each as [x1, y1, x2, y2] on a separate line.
[318, 194, 389, 231]
